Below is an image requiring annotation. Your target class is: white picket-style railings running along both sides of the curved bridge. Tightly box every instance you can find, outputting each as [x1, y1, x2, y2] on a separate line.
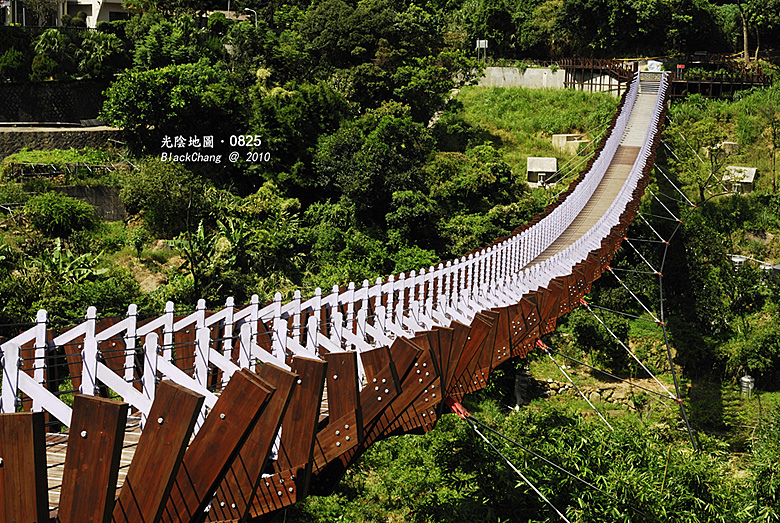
[0, 73, 667, 432]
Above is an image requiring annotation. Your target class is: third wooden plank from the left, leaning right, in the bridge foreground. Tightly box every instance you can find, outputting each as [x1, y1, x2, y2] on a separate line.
[113, 380, 204, 523]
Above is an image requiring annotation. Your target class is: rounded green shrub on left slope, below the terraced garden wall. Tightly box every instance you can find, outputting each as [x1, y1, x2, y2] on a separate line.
[24, 191, 98, 237]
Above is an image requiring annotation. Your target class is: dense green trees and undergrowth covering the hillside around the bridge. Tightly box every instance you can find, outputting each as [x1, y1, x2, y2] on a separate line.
[0, 0, 780, 522]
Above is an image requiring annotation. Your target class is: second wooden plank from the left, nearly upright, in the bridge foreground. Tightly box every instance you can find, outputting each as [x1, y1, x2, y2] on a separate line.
[58, 394, 128, 523]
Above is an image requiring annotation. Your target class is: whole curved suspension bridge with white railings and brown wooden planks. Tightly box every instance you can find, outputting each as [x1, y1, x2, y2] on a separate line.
[0, 73, 668, 523]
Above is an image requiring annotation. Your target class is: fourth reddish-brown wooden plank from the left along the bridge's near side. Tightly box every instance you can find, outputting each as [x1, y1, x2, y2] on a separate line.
[162, 369, 276, 522]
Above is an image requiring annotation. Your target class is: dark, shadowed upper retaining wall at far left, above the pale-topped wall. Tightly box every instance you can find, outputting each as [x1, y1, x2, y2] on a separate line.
[0, 80, 109, 123]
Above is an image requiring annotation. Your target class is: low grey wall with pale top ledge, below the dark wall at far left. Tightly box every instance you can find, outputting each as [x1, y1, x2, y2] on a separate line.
[0, 127, 122, 161]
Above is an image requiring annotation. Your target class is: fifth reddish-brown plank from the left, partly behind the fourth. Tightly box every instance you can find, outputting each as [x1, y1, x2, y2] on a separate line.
[208, 363, 298, 521]
